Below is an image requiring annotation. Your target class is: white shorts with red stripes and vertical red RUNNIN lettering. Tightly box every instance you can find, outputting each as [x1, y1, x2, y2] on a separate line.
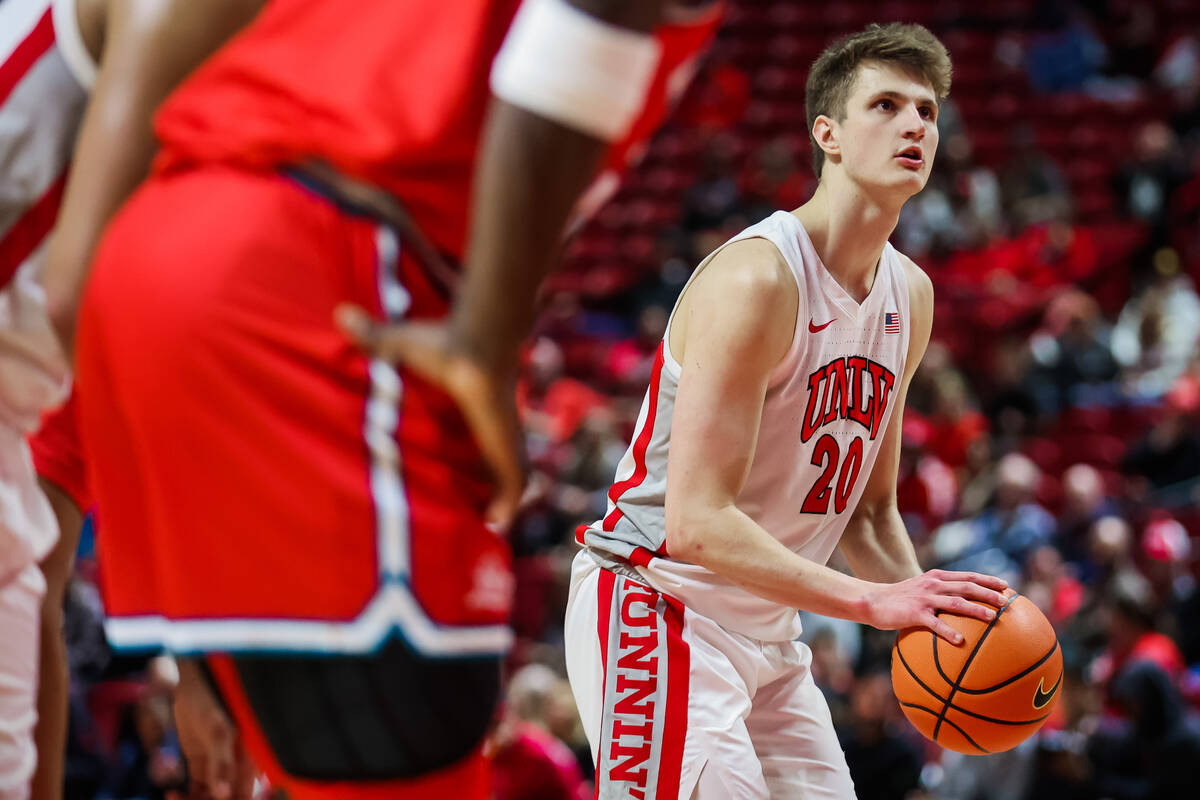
[566, 551, 854, 800]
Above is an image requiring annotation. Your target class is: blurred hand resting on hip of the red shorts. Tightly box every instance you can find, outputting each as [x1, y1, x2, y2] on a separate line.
[335, 305, 524, 531]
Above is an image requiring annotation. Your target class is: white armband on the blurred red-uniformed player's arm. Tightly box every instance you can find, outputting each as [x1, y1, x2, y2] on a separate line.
[491, 0, 661, 142]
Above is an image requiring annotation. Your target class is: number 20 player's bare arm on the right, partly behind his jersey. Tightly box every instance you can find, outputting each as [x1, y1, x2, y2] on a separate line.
[839, 254, 934, 583]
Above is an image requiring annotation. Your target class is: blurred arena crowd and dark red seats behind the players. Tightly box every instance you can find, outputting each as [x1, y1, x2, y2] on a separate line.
[58, 0, 1200, 800]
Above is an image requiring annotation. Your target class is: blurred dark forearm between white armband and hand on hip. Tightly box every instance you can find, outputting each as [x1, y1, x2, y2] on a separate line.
[450, 101, 605, 374]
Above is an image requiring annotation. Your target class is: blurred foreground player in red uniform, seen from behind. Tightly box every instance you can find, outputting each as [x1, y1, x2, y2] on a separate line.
[48, 0, 716, 798]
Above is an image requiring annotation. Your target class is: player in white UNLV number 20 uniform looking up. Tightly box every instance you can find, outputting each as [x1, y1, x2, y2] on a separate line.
[556, 24, 1006, 800]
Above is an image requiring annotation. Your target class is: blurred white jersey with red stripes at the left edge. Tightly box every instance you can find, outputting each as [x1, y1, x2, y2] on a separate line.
[0, 0, 95, 582]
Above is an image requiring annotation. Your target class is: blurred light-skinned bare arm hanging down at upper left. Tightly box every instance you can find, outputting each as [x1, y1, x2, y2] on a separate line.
[44, 0, 263, 351]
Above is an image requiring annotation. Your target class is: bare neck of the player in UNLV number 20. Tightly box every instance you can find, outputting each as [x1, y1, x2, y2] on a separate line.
[792, 179, 900, 302]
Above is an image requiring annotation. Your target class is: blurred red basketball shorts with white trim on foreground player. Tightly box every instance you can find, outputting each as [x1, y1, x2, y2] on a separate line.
[77, 167, 512, 656]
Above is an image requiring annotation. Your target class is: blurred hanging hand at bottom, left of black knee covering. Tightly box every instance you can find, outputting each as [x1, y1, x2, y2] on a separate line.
[175, 661, 254, 800]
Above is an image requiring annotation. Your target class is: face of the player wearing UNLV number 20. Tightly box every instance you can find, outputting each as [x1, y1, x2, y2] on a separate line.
[838, 62, 937, 200]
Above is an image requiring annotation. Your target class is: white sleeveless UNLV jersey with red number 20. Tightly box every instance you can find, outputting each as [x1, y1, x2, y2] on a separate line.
[576, 211, 911, 642]
